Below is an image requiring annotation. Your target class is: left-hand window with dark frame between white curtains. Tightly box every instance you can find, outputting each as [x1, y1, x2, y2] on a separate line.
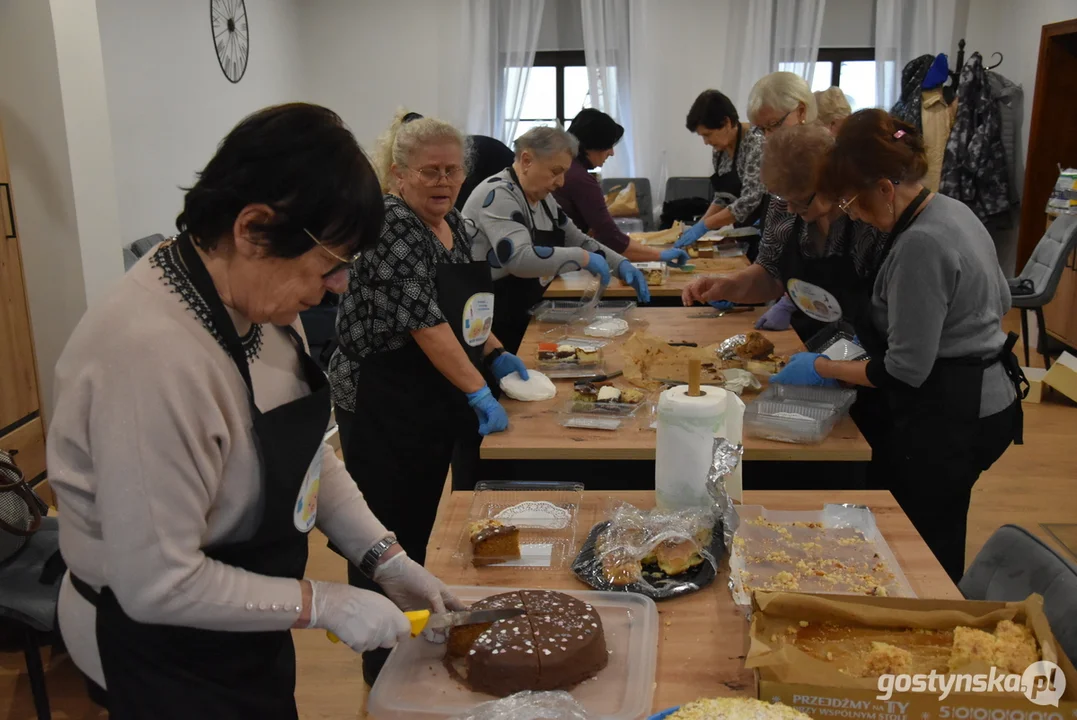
[505, 51, 591, 140]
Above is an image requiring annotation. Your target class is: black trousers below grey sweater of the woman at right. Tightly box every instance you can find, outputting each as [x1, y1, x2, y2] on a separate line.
[865, 399, 1021, 583]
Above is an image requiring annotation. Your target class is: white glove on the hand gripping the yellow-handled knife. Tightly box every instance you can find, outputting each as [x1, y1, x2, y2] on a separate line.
[309, 580, 411, 652]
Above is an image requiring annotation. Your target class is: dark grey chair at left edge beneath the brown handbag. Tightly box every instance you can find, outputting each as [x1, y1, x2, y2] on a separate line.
[0, 518, 62, 720]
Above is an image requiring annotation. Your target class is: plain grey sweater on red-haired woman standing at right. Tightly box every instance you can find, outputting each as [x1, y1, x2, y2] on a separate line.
[869, 195, 1016, 418]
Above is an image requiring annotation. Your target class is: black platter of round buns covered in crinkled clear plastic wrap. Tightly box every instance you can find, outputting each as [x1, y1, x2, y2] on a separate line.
[572, 503, 726, 599]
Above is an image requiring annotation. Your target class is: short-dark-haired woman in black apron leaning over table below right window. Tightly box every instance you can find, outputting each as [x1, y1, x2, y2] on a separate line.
[674, 90, 766, 249]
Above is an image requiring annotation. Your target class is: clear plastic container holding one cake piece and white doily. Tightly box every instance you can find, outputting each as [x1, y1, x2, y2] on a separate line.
[453, 481, 584, 569]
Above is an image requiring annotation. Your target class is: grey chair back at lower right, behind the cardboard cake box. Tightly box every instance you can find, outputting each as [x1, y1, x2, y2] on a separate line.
[957, 525, 1077, 660]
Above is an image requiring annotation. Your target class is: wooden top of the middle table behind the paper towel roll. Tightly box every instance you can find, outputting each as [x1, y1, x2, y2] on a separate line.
[481, 308, 871, 462]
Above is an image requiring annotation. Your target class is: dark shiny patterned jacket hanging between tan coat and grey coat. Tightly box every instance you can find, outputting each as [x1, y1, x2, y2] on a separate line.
[939, 53, 1010, 221]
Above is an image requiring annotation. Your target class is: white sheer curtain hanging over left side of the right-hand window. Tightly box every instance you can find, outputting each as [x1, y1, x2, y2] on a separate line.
[725, 0, 826, 113]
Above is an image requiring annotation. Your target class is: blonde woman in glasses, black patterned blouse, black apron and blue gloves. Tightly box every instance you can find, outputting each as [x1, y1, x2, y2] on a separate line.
[330, 113, 528, 684]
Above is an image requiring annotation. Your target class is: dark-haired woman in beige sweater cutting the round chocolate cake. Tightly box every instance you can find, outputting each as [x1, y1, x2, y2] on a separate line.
[48, 104, 460, 719]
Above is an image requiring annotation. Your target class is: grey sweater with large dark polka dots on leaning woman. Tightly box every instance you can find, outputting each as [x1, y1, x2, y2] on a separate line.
[464, 169, 625, 280]
